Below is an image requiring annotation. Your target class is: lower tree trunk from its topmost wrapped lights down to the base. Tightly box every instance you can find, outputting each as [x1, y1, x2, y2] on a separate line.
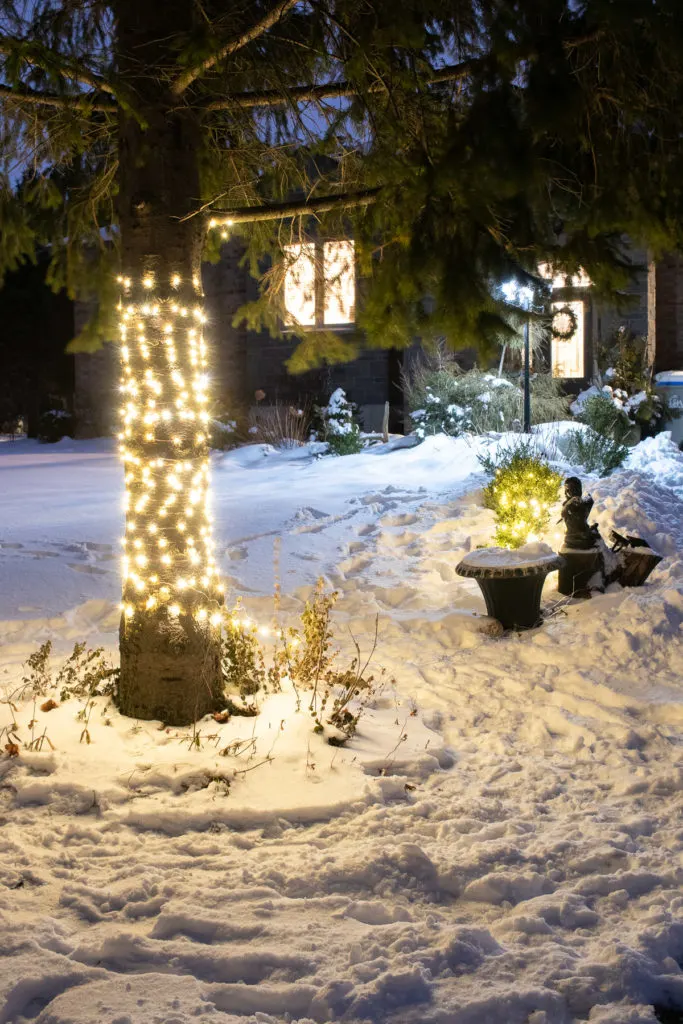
[119, 270, 223, 724]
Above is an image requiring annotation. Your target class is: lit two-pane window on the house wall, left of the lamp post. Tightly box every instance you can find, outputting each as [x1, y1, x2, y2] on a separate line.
[285, 239, 355, 327]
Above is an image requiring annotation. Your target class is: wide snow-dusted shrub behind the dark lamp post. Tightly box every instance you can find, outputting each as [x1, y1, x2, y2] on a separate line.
[404, 364, 567, 437]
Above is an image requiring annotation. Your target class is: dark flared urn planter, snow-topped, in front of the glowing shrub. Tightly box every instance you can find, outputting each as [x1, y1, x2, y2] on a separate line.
[456, 548, 563, 630]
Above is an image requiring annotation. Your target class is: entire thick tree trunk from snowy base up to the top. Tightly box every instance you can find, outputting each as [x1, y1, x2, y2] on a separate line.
[114, 0, 223, 725]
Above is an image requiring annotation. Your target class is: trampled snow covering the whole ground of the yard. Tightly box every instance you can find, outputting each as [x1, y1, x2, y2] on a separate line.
[0, 428, 683, 1024]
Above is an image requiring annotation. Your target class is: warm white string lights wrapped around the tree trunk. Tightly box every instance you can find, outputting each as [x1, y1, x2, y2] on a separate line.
[118, 271, 224, 627]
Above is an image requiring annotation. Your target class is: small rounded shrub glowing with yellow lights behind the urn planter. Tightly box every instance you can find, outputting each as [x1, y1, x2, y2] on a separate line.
[479, 439, 562, 548]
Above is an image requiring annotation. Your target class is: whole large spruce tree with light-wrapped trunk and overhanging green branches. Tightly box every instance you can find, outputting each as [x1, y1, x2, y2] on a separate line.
[0, 0, 683, 723]
